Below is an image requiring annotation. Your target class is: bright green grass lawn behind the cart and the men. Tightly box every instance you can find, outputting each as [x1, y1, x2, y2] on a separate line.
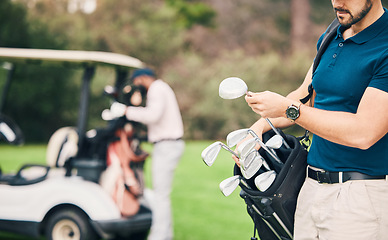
[0, 141, 253, 240]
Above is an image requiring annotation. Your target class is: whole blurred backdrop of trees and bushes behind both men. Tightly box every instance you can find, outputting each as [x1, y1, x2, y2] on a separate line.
[0, 0, 388, 141]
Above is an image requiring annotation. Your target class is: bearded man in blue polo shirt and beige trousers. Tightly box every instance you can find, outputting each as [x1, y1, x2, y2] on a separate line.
[239, 0, 388, 240]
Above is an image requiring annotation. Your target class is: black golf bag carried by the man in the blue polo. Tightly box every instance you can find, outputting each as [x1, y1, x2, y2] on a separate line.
[234, 131, 307, 240]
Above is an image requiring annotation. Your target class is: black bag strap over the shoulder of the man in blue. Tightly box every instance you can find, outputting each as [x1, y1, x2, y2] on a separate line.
[300, 18, 340, 104]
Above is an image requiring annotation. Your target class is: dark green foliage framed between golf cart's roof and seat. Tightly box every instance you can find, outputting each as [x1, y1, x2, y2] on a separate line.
[5, 64, 79, 142]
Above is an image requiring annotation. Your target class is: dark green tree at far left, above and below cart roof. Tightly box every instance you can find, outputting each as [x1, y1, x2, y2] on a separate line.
[0, 0, 79, 141]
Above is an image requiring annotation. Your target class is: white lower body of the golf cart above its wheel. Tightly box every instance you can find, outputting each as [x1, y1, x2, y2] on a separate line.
[0, 169, 121, 236]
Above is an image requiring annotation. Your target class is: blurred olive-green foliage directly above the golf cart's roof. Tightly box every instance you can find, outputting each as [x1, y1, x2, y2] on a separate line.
[22, 0, 215, 69]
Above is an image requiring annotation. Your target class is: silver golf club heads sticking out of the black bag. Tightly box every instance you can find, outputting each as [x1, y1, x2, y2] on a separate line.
[201, 129, 284, 196]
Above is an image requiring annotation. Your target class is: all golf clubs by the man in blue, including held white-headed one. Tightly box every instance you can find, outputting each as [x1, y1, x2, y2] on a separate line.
[201, 77, 290, 196]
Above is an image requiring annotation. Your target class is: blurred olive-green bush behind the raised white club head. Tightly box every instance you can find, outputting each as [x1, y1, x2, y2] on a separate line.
[163, 51, 312, 139]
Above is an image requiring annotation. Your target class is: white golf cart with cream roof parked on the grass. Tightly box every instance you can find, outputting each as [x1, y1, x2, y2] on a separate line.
[0, 48, 152, 240]
